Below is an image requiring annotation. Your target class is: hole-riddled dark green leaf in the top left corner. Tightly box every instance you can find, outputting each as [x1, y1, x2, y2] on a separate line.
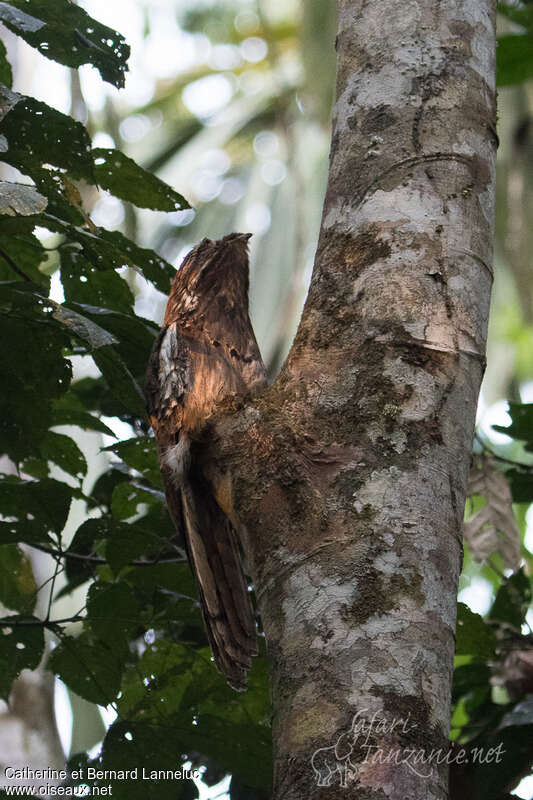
[0, 0, 130, 88]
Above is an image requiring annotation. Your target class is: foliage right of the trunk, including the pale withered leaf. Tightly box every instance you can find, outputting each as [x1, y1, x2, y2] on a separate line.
[451, 410, 533, 800]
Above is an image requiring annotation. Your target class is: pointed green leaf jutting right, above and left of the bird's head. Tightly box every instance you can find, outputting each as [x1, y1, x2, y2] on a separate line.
[93, 148, 190, 211]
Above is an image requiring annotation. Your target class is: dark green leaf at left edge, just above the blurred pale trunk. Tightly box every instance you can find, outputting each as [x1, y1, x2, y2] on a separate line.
[0, 616, 44, 700]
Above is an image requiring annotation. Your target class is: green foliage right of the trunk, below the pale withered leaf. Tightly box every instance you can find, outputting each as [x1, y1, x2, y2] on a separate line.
[451, 570, 533, 800]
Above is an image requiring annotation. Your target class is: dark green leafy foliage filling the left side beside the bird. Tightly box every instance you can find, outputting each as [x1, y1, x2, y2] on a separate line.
[0, 0, 270, 798]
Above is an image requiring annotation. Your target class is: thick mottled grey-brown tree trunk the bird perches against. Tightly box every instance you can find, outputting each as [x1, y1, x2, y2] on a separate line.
[207, 0, 497, 800]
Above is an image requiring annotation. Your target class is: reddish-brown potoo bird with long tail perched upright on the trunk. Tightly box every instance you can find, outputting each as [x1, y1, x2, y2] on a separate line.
[145, 233, 266, 689]
